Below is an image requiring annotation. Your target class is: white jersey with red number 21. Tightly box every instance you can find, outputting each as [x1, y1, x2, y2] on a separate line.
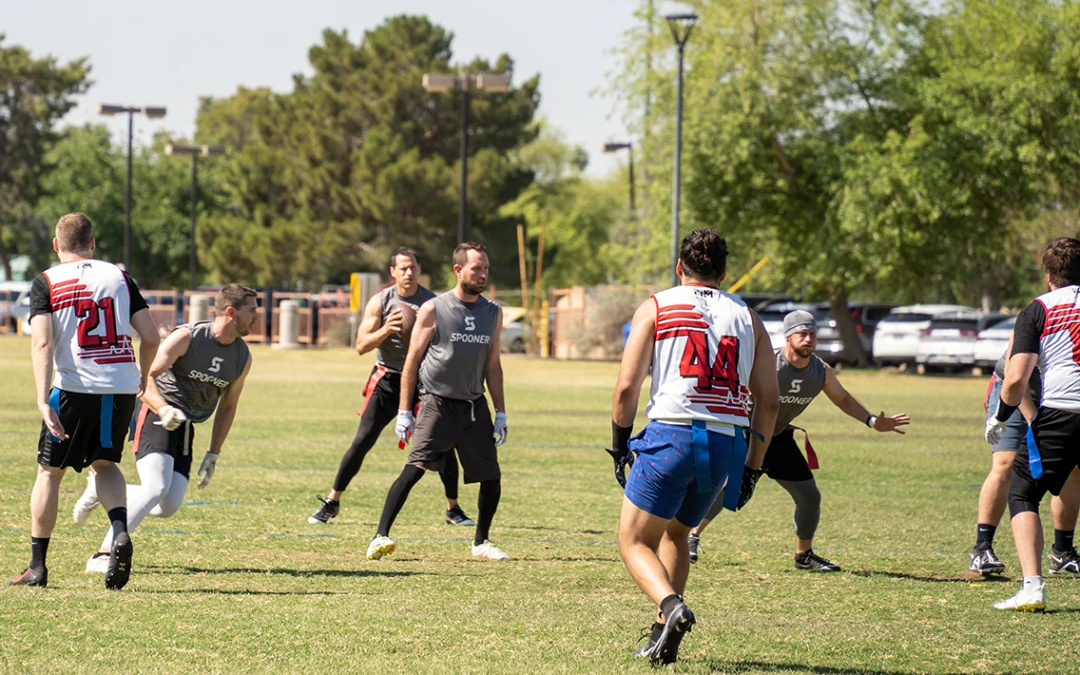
[43, 259, 141, 394]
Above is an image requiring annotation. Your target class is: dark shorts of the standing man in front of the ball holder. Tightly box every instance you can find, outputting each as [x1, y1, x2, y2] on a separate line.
[407, 394, 502, 483]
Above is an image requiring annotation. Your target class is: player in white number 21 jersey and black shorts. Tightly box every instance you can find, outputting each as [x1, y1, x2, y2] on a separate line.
[11, 213, 161, 590]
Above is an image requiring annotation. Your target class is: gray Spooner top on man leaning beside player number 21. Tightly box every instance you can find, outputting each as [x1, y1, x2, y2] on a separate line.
[154, 321, 251, 422]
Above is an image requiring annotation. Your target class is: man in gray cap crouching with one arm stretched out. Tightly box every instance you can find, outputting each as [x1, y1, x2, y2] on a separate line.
[689, 310, 909, 571]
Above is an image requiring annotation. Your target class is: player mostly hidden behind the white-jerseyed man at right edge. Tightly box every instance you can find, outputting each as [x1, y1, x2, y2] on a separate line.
[970, 340, 1080, 575]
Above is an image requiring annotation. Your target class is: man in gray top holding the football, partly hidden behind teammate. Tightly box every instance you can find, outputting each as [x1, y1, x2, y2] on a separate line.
[308, 247, 476, 526]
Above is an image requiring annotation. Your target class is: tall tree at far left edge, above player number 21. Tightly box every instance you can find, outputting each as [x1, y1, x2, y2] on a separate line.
[0, 33, 90, 279]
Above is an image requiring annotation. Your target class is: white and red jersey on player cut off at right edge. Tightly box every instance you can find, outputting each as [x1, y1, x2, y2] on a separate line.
[1036, 286, 1080, 413]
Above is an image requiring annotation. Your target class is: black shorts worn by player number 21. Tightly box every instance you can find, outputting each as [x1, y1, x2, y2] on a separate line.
[38, 388, 135, 472]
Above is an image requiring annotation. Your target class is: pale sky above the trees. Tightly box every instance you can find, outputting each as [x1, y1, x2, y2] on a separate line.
[0, 0, 638, 176]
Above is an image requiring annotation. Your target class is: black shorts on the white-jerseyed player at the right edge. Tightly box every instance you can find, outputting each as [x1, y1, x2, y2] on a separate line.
[1009, 407, 1080, 514]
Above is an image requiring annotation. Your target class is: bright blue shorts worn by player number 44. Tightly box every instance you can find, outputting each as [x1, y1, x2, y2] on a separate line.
[624, 422, 734, 527]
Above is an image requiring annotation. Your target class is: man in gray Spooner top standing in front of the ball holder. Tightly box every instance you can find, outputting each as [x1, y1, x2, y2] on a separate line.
[367, 243, 510, 561]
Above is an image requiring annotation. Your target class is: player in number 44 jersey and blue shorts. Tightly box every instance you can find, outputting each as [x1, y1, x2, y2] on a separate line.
[611, 230, 780, 664]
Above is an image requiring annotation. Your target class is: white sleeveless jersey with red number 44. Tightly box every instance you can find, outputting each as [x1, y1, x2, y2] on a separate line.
[645, 286, 754, 435]
